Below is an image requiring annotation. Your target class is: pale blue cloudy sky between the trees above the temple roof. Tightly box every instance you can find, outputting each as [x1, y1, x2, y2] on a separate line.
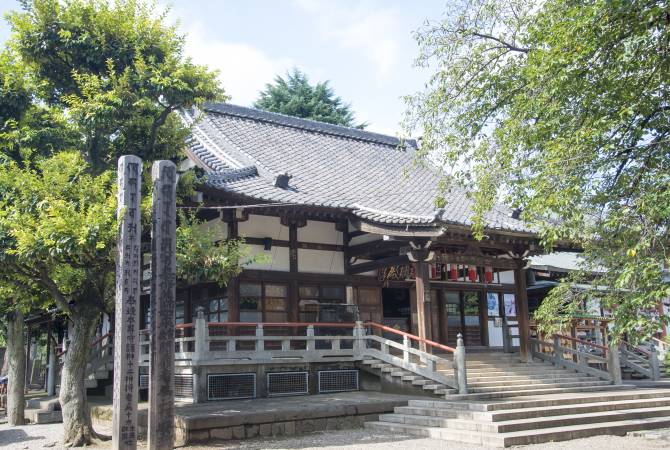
[0, 0, 447, 134]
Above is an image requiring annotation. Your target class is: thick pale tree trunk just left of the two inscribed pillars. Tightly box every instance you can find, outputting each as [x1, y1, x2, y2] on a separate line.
[59, 307, 98, 447]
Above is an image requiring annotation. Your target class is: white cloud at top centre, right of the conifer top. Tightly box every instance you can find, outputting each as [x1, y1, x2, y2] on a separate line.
[295, 0, 405, 78]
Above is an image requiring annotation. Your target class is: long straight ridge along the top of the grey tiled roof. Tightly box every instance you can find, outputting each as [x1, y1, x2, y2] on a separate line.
[203, 103, 417, 148]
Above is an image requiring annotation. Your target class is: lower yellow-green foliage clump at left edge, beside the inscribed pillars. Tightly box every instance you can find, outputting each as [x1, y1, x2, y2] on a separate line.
[0, 151, 116, 312]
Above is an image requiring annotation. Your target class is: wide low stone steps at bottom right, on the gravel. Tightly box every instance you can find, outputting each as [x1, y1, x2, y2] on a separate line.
[365, 389, 670, 447]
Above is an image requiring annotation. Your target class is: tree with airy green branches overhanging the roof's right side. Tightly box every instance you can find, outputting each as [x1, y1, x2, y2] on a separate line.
[406, 0, 670, 340]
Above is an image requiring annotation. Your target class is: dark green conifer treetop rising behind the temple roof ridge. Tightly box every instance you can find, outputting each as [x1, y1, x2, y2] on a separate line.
[254, 69, 368, 129]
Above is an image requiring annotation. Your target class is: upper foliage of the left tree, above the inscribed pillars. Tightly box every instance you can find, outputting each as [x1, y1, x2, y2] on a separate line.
[8, 0, 224, 171]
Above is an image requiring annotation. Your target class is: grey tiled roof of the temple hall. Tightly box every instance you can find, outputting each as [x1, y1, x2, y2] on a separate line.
[182, 103, 531, 233]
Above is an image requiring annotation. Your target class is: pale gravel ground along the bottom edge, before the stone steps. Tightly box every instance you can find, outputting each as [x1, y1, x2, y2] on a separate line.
[0, 424, 670, 450]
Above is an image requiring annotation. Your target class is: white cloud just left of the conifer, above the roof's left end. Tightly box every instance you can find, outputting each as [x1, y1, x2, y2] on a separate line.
[185, 24, 295, 105]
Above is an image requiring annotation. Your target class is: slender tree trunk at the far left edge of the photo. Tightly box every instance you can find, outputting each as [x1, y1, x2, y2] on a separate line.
[7, 312, 26, 425]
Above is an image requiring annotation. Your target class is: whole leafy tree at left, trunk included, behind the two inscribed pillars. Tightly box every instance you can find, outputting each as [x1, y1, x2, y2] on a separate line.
[0, 0, 239, 446]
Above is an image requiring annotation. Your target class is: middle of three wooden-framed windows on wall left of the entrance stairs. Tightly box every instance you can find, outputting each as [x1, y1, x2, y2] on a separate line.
[240, 283, 288, 322]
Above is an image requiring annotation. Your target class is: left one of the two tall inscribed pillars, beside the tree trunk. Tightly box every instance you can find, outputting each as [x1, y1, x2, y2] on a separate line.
[112, 155, 142, 450]
